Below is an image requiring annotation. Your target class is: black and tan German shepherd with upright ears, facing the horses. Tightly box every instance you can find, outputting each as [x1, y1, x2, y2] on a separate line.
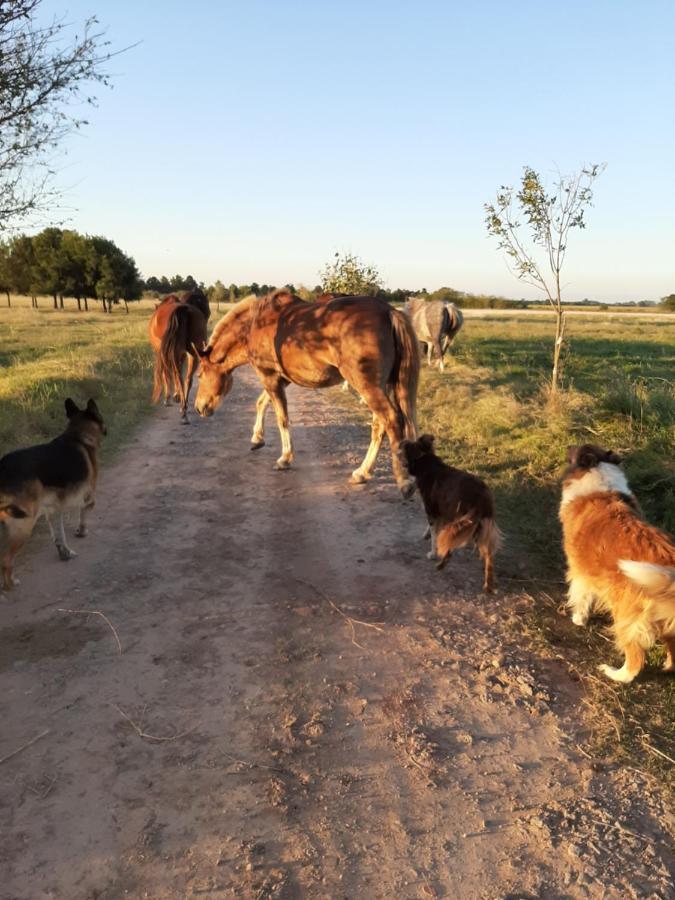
[0, 398, 106, 591]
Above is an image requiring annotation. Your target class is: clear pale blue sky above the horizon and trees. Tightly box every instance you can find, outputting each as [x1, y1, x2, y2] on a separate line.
[45, 0, 675, 300]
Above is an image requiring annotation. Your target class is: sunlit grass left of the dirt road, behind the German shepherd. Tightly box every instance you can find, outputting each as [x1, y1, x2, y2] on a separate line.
[0, 306, 152, 460]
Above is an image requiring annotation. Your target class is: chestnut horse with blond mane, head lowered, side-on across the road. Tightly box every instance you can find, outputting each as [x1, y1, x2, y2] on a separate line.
[195, 290, 420, 496]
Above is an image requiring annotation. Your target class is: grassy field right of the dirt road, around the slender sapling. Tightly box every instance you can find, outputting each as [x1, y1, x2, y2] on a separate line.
[336, 314, 675, 787]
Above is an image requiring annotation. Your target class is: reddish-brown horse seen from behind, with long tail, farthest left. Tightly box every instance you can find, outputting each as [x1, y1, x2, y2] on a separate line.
[149, 288, 211, 423]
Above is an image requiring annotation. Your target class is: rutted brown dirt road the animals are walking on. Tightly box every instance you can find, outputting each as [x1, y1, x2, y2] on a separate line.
[0, 374, 675, 900]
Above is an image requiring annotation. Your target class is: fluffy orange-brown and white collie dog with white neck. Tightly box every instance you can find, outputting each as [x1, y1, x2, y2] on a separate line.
[560, 444, 675, 684]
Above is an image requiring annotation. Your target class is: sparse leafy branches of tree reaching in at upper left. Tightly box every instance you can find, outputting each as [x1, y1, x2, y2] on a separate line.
[0, 0, 119, 230]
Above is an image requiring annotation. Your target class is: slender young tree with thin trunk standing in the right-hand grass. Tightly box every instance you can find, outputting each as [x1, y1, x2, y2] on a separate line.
[485, 165, 604, 392]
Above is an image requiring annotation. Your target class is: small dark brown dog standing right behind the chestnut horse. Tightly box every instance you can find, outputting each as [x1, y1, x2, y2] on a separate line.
[401, 434, 502, 593]
